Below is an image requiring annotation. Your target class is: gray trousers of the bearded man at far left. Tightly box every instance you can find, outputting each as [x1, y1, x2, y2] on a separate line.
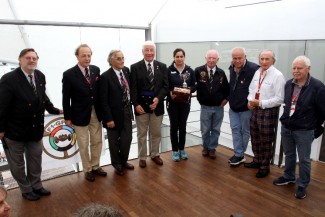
[4, 138, 43, 193]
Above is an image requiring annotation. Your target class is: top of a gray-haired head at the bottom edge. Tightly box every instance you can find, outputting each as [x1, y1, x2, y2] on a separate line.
[75, 203, 123, 217]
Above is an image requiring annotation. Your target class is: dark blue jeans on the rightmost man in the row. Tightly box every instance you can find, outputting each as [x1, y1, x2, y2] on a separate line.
[281, 126, 314, 188]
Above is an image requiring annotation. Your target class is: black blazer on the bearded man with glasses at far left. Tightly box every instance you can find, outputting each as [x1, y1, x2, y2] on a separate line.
[0, 67, 60, 142]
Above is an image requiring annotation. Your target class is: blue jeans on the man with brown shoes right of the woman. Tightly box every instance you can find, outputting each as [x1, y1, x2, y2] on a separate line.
[200, 105, 223, 150]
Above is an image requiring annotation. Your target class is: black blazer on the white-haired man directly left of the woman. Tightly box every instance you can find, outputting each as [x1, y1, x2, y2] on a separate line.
[130, 60, 169, 116]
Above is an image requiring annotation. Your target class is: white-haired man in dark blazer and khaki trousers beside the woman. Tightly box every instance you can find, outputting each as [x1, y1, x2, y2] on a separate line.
[130, 41, 169, 168]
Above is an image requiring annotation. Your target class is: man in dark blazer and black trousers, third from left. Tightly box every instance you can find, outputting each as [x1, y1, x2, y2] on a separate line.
[100, 50, 134, 176]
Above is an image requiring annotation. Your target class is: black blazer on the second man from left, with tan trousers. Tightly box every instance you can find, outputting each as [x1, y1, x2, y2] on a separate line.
[62, 65, 101, 126]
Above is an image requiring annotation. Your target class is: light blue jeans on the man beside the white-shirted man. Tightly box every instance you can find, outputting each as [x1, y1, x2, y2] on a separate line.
[229, 109, 252, 157]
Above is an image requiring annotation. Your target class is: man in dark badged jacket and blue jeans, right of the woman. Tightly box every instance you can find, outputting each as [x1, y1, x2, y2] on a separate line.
[195, 50, 229, 159]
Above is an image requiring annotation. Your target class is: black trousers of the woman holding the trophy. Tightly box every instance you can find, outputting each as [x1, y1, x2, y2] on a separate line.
[167, 101, 191, 151]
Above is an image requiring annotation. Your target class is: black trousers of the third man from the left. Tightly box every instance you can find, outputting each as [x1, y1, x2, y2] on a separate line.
[107, 109, 132, 167]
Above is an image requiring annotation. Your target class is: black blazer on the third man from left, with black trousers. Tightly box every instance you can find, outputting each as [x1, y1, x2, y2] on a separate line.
[99, 67, 131, 130]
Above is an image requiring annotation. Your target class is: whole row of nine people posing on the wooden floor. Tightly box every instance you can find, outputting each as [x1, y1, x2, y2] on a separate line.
[0, 41, 325, 201]
